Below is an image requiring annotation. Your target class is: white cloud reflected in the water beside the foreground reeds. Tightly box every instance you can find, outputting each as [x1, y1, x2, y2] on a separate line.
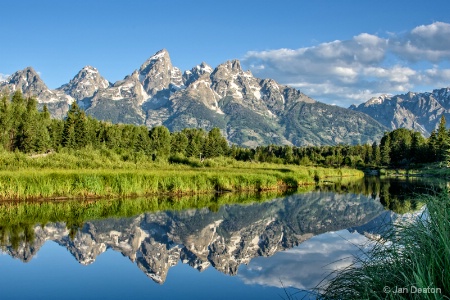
[238, 230, 370, 289]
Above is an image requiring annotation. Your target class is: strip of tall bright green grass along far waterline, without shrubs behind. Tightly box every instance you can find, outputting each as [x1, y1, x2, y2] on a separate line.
[0, 161, 363, 200]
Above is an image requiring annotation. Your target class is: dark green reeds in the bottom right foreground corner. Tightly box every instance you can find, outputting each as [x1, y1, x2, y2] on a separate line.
[319, 192, 450, 299]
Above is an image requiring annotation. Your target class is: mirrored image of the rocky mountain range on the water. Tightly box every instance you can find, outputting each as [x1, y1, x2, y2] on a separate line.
[0, 192, 384, 283]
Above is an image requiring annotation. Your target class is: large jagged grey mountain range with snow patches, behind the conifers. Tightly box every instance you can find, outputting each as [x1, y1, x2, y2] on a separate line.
[0, 49, 386, 147]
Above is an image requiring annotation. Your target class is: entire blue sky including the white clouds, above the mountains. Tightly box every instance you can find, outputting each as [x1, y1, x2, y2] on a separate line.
[0, 0, 450, 107]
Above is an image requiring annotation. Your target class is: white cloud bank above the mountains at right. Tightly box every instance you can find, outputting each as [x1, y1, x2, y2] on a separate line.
[243, 22, 450, 107]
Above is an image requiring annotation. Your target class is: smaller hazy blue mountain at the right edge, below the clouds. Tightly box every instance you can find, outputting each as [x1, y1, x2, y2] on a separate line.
[350, 88, 450, 136]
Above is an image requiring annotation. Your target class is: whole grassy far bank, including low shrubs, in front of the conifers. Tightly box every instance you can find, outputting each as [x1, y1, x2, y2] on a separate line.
[0, 149, 364, 200]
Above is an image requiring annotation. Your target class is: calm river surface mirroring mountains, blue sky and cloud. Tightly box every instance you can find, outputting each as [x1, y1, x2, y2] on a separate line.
[0, 178, 442, 299]
